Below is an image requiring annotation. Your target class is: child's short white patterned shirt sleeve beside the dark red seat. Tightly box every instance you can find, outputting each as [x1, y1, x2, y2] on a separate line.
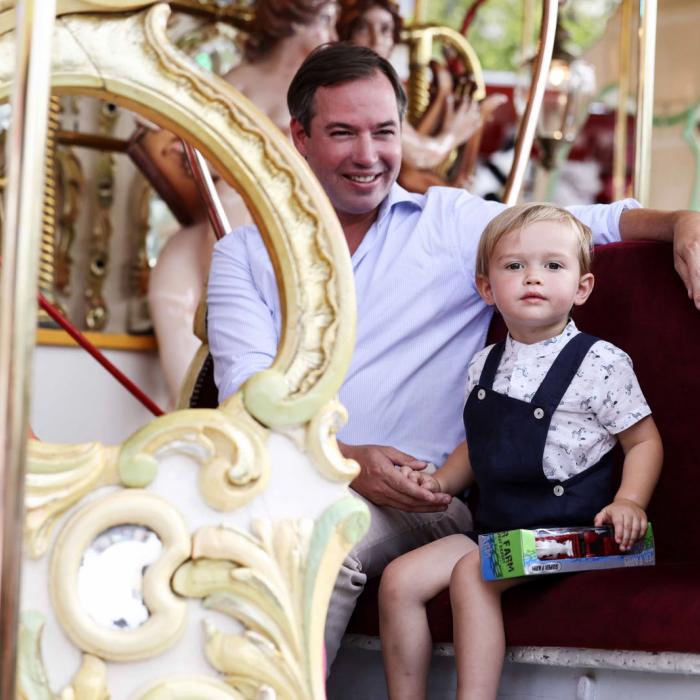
[585, 341, 651, 435]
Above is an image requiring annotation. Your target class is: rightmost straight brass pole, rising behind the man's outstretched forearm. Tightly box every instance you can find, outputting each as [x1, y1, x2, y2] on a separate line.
[634, 0, 657, 206]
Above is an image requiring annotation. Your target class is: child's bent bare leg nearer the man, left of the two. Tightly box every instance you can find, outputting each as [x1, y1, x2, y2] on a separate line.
[379, 535, 476, 700]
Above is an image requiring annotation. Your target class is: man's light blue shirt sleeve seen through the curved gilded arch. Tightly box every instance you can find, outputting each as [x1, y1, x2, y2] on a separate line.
[207, 226, 280, 401]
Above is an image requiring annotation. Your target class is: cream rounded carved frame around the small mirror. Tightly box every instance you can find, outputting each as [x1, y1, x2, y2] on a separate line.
[50, 489, 190, 661]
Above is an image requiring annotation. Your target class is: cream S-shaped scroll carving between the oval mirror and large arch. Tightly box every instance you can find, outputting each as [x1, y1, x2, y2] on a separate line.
[118, 398, 270, 511]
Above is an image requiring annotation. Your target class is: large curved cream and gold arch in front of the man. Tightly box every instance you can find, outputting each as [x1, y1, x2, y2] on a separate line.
[0, 2, 355, 426]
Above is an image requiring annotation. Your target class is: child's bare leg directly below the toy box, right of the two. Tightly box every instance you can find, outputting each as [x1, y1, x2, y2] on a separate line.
[450, 549, 521, 700]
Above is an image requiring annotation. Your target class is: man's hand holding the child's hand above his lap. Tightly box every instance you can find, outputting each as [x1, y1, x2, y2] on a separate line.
[338, 442, 452, 513]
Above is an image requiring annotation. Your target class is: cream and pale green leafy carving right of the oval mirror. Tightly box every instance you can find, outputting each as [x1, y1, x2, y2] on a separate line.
[173, 497, 369, 700]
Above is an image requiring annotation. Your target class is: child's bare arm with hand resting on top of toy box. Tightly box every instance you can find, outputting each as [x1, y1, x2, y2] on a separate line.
[594, 416, 663, 550]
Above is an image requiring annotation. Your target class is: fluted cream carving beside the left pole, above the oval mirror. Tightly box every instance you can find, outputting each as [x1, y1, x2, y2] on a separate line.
[24, 440, 119, 558]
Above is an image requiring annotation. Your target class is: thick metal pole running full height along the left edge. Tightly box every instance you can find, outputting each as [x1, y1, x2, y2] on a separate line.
[0, 0, 56, 700]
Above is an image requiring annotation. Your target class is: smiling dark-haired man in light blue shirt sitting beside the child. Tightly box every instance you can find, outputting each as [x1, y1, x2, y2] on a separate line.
[208, 44, 700, 664]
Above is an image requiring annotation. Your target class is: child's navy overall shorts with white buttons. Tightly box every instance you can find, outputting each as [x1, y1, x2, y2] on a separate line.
[464, 333, 615, 532]
